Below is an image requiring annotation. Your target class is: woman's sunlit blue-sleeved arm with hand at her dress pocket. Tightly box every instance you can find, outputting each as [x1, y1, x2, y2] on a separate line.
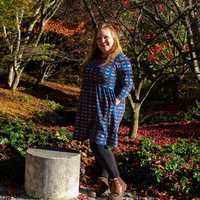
[115, 54, 133, 104]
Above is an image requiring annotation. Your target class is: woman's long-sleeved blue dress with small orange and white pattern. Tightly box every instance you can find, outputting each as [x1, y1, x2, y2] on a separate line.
[73, 52, 133, 147]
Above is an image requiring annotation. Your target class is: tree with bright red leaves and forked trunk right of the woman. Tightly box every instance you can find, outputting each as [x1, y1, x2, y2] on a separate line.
[82, 0, 200, 137]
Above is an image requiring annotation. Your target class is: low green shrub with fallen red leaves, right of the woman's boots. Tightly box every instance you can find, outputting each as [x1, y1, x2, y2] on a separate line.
[118, 138, 200, 195]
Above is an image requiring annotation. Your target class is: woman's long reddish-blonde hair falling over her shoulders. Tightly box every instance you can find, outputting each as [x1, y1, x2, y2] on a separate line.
[83, 23, 122, 67]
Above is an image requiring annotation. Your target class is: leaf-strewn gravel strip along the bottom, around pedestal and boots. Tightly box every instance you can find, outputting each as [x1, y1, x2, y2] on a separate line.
[0, 186, 155, 200]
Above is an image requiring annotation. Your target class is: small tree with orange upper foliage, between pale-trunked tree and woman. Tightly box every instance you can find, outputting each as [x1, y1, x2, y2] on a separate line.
[34, 19, 85, 84]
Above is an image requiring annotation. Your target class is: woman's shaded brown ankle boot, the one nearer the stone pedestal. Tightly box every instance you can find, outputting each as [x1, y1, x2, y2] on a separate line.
[86, 177, 110, 197]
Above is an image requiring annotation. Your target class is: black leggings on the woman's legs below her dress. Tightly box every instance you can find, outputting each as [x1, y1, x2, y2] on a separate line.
[90, 143, 119, 179]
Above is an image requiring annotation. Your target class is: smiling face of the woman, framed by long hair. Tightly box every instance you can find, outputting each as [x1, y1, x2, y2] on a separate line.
[96, 28, 114, 57]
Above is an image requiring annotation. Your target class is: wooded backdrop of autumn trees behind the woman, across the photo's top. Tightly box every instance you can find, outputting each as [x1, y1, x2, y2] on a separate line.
[0, 0, 200, 137]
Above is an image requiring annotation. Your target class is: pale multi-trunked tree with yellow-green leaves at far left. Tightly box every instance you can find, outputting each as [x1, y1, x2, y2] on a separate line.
[0, 0, 62, 90]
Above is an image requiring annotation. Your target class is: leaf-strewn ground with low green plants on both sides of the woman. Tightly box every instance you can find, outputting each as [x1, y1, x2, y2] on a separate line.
[0, 74, 200, 199]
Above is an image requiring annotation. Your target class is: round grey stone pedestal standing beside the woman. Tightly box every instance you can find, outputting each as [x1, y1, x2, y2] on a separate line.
[24, 147, 80, 200]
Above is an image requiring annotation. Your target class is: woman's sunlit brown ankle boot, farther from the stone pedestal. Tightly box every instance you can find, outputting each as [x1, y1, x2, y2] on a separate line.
[109, 177, 127, 200]
